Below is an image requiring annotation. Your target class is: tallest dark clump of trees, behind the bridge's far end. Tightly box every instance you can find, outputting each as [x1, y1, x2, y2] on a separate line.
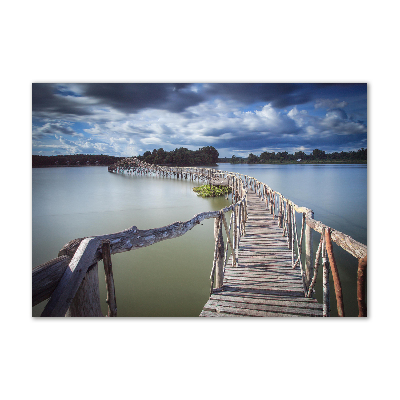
[138, 146, 219, 166]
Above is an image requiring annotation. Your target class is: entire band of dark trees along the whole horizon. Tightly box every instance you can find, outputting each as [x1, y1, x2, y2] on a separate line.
[32, 146, 367, 168]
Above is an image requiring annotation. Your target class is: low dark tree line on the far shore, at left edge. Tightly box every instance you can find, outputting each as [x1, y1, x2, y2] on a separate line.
[32, 154, 125, 168]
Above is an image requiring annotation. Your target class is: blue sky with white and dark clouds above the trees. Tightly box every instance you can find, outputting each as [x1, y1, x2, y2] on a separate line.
[32, 83, 367, 157]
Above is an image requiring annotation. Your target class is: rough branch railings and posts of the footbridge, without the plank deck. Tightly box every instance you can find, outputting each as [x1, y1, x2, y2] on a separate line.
[32, 157, 367, 317]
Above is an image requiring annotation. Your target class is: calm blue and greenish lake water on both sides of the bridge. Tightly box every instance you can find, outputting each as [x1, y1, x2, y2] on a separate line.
[32, 164, 367, 317]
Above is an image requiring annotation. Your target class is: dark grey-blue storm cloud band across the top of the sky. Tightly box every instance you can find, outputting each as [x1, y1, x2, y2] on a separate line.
[32, 83, 366, 116]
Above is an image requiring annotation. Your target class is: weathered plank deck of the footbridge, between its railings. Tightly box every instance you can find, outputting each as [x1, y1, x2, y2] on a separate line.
[200, 191, 322, 317]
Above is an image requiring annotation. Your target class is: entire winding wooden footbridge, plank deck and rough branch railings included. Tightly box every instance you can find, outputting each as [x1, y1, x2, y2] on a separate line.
[32, 158, 367, 317]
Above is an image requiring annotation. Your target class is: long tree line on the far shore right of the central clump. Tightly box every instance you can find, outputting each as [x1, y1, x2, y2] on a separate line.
[219, 148, 367, 164]
